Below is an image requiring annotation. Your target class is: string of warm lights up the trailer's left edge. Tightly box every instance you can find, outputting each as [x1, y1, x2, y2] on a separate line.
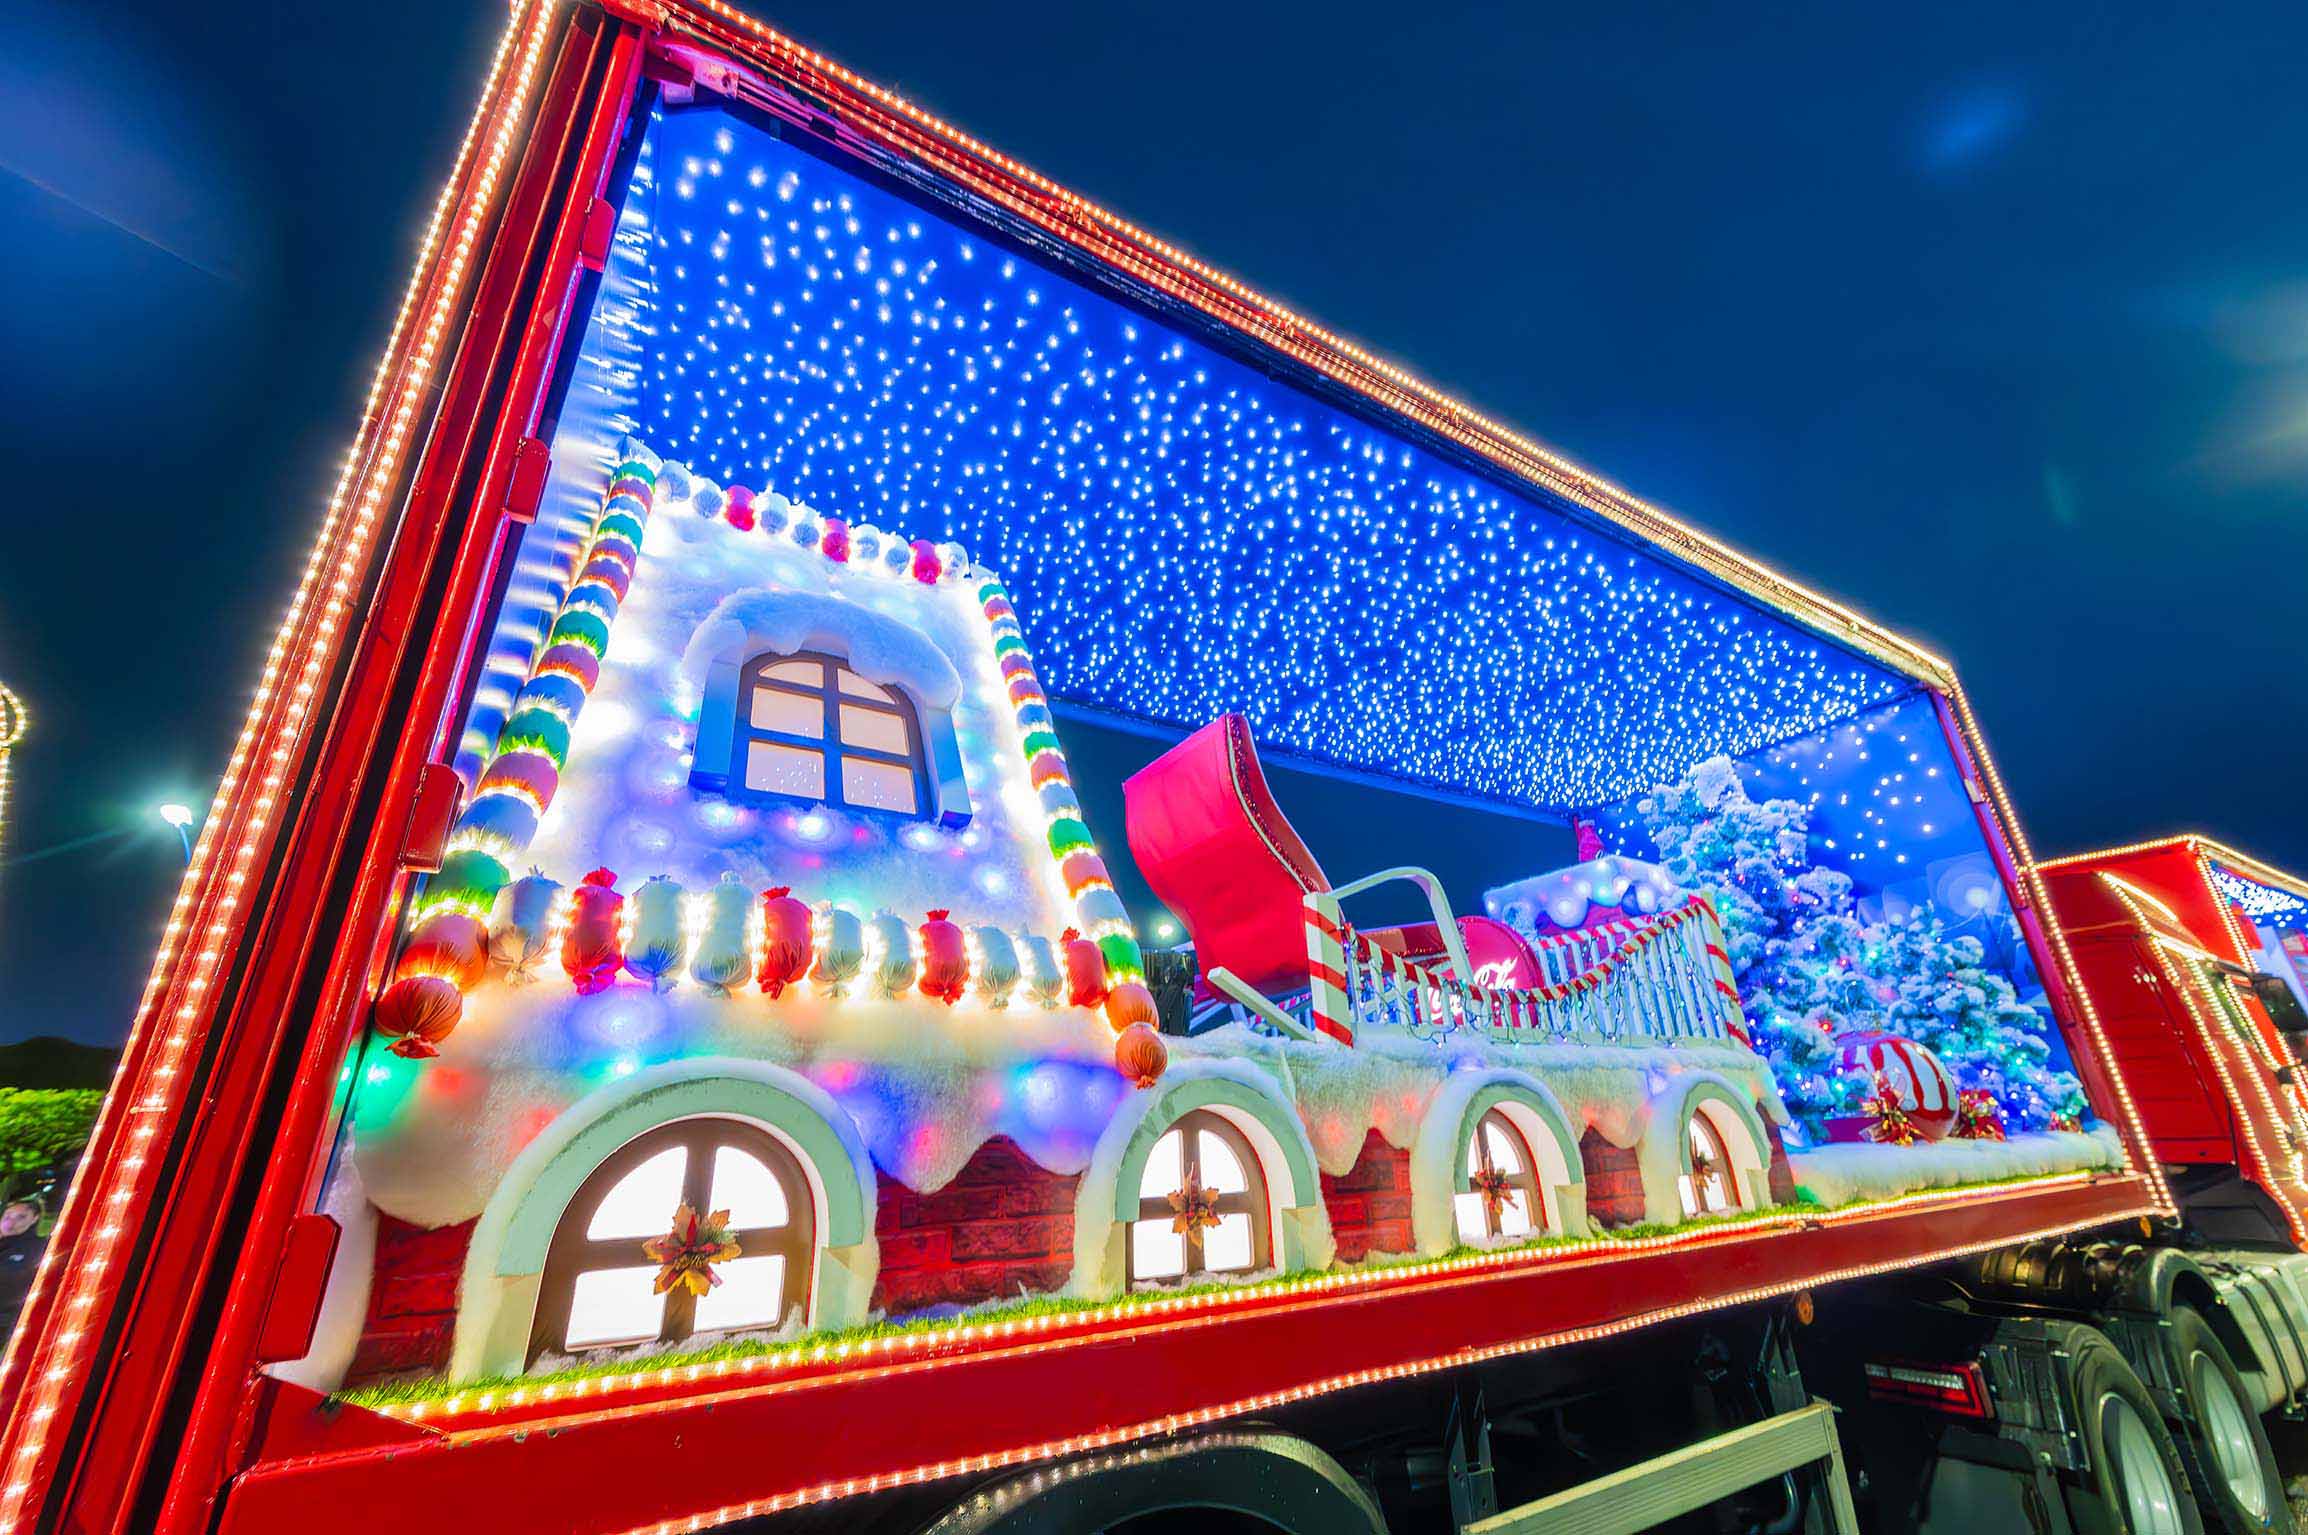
[0, 0, 556, 1535]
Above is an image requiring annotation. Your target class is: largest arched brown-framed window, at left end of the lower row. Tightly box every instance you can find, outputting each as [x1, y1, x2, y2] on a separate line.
[529, 1120, 815, 1360]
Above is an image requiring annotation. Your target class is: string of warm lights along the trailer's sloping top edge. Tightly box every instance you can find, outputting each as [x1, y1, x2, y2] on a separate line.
[669, 0, 1955, 688]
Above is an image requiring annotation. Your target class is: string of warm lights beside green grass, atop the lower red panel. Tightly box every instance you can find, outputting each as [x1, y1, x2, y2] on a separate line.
[369, 1170, 2110, 1424]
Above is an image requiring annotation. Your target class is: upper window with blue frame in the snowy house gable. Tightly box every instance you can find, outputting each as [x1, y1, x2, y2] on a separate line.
[729, 651, 937, 819]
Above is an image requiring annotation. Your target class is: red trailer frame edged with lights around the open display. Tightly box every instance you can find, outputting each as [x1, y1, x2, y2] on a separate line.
[0, 0, 2172, 1535]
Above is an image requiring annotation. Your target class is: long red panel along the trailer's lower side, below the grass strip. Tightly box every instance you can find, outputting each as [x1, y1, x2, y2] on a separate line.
[219, 1177, 2151, 1535]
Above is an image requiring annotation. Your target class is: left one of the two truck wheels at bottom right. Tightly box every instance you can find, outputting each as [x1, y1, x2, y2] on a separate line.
[2059, 1325, 2204, 1535]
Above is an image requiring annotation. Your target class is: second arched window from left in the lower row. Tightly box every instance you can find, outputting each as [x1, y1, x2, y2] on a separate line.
[1131, 1108, 1269, 1283]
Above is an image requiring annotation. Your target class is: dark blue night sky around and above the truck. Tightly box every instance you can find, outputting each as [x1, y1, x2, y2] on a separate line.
[0, 0, 2308, 1041]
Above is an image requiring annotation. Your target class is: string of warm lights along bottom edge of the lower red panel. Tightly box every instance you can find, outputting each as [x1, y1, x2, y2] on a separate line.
[581, 1221, 2141, 1535]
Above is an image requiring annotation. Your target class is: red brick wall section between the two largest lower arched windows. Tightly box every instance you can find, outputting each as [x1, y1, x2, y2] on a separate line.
[872, 1136, 1082, 1316]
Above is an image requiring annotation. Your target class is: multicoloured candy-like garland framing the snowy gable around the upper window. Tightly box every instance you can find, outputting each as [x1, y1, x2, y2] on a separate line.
[374, 436, 1168, 1087]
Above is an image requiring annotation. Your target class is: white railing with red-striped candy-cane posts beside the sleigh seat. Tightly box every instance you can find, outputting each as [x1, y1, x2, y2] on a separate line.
[1306, 893, 1747, 1043]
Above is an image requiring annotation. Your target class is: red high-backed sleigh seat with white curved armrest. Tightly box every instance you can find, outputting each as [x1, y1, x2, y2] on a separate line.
[1122, 713, 1542, 1013]
